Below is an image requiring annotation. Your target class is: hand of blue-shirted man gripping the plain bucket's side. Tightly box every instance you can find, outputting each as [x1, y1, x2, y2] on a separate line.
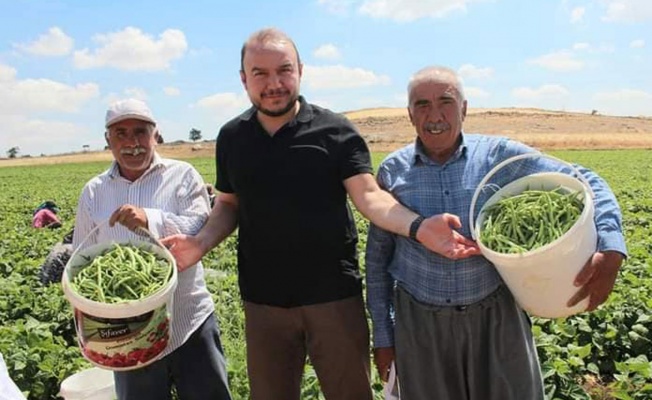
[566, 251, 624, 311]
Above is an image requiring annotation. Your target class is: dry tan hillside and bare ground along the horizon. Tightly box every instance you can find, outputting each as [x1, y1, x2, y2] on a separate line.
[0, 108, 652, 167]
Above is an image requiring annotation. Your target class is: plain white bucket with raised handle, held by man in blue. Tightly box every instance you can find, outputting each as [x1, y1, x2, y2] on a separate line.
[469, 153, 597, 318]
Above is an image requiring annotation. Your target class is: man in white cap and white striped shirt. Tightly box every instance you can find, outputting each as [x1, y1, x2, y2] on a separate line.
[73, 99, 231, 400]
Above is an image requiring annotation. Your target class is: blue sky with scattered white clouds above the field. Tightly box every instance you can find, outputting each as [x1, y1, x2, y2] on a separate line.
[0, 0, 652, 156]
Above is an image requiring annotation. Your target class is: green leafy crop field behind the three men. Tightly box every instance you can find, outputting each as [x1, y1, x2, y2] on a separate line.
[0, 150, 652, 400]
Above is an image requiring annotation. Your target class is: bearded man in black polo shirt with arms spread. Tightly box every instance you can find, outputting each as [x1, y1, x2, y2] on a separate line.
[163, 29, 479, 400]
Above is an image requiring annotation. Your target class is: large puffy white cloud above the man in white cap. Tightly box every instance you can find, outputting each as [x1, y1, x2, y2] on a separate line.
[74, 27, 188, 71]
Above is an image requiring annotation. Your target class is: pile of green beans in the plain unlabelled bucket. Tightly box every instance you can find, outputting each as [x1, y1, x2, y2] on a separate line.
[480, 188, 584, 253]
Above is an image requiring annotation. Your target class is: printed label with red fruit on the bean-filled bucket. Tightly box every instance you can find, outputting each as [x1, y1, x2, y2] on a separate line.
[75, 304, 170, 370]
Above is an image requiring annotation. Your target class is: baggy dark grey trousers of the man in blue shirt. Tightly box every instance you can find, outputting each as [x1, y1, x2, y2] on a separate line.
[395, 286, 544, 400]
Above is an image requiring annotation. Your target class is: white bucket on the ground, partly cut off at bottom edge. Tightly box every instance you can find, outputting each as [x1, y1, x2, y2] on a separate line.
[59, 368, 116, 400]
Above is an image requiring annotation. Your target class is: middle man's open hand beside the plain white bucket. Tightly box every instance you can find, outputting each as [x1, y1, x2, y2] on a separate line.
[417, 213, 480, 259]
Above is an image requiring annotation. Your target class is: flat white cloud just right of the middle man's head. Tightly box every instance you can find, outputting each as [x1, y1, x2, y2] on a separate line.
[303, 65, 390, 89]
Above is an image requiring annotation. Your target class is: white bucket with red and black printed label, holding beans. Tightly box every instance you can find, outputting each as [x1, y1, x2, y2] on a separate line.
[61, 231, 177, 371]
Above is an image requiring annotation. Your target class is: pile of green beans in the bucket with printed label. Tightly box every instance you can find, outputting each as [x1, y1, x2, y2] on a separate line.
[71, 244, 173, 304]
